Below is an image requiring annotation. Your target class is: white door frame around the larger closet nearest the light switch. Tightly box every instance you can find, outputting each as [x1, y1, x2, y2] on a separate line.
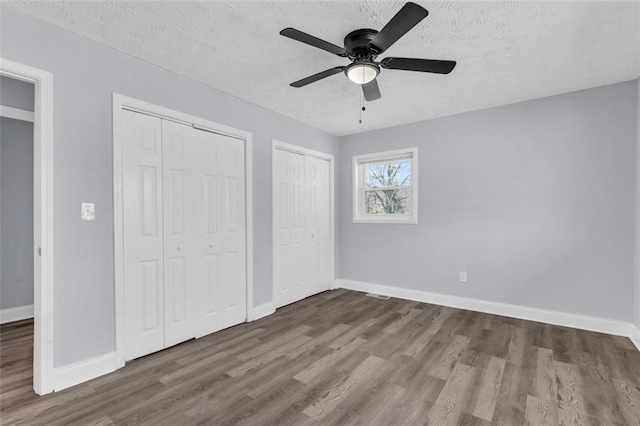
[113, 93, 254, 368]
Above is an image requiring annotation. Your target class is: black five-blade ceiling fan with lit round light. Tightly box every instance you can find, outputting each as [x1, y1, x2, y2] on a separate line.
[280, 2, 456, 101]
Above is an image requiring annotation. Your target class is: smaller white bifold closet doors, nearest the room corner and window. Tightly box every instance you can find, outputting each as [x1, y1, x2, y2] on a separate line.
[273, 149, 331, 307]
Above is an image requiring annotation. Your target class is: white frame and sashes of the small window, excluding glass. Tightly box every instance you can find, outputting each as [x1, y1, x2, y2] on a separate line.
[351, 147, 418, 224]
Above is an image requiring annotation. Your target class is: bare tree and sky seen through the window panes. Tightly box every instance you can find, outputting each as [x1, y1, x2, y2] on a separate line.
[365, 160, 411, 215]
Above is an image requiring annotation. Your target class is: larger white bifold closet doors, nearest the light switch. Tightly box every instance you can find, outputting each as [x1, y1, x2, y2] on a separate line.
[123, 111, 246, 360]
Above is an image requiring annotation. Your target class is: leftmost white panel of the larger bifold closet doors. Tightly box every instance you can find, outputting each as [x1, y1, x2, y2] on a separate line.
[122, 111, 165, 360]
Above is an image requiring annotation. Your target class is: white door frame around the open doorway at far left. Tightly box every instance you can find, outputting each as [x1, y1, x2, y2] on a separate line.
[0, 58, 53, 395]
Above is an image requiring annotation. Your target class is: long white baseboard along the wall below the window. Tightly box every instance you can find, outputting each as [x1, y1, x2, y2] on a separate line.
[338, 280, 640, 350]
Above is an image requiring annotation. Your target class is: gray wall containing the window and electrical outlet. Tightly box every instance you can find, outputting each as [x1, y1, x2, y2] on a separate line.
[338, 81, 638, 321]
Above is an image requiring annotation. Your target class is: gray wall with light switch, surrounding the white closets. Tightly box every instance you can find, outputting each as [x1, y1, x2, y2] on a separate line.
[0, 8, 337, 367]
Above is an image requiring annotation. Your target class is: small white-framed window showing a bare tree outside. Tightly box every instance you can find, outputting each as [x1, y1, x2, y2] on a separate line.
[353, 148, 418, 223]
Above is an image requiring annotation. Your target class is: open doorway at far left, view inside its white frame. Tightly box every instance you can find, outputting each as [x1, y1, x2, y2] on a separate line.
[0, 76, 35, 402]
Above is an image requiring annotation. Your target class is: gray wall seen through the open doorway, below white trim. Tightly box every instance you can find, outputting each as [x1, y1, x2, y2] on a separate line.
[0, 116, 33, 309]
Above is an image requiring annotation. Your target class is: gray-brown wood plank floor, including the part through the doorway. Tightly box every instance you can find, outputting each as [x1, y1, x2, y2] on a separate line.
[0, 290, 640, 426]
